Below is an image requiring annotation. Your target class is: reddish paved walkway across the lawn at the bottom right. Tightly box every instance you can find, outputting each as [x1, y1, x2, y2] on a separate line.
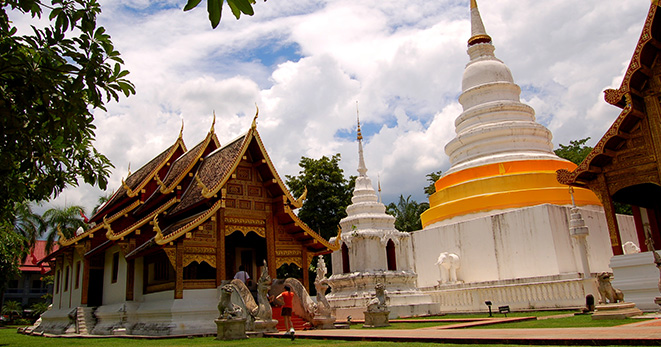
[267, 320, 661, 346]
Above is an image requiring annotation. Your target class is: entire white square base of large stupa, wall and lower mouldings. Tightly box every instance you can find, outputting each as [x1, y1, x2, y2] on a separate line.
[412, 204, 636, 312]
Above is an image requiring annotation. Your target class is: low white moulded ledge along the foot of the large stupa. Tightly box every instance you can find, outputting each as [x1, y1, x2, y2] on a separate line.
[423, 276, 584, 312]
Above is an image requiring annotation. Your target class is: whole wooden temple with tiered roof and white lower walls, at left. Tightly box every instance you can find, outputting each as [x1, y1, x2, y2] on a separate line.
[42, 116, 337, 335]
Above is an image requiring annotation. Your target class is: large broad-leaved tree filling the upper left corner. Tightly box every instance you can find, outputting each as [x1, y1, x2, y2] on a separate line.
[0, 0, 135, 226]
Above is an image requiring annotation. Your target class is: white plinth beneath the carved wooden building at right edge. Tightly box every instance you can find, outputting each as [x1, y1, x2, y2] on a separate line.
[610, 252, 661, 312]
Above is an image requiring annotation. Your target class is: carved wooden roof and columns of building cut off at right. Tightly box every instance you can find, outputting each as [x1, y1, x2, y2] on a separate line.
[558, 0, 661, 255]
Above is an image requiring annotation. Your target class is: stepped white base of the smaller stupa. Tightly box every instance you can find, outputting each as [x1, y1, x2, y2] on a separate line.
[326, 271, 441, 320]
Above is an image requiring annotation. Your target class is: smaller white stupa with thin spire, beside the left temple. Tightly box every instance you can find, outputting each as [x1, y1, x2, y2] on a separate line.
[327, 109, 440, 319]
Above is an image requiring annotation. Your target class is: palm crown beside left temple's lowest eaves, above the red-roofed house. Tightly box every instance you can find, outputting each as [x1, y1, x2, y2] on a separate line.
[42, 205, 87, 253]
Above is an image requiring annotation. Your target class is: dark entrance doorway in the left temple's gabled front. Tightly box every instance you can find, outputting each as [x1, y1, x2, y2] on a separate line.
[225, 230, 266, 282]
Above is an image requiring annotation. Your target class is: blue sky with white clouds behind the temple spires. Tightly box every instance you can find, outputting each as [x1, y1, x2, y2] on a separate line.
[32, 0, 650, 216]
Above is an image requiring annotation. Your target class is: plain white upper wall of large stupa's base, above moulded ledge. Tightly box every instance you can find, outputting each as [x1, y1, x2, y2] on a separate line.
[412, 204, 635, 287]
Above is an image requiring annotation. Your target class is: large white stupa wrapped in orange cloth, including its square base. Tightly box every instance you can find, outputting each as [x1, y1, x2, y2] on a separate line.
[412, 0, 628, 312]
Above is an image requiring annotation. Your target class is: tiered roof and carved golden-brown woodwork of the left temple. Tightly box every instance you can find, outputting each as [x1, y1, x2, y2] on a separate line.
[47, 118, 337, 306]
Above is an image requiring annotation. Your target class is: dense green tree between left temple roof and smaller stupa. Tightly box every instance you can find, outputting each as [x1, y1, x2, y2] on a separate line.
[285, 154, 355, 240]
